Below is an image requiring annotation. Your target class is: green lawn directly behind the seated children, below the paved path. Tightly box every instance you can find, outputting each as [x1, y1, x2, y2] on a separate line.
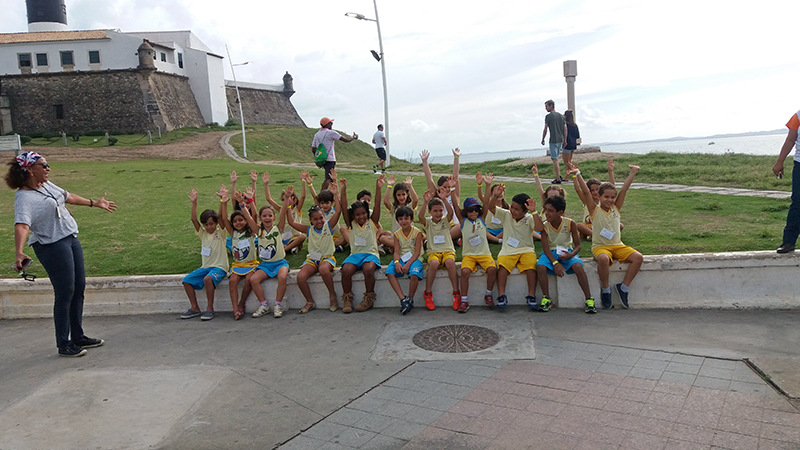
[0, 158, 789, 277]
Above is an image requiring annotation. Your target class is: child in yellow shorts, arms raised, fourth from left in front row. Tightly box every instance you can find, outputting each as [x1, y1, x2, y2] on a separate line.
[284, 169, 341, 314]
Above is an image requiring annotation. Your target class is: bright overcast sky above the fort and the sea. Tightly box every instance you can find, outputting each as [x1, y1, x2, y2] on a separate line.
[0, 0, 800, 157]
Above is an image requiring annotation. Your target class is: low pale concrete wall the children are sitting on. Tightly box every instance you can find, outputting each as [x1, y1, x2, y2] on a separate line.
[0, 251, 800, 319]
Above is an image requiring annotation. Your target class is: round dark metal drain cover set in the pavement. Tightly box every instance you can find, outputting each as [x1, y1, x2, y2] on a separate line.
[412, 325, 500, 353]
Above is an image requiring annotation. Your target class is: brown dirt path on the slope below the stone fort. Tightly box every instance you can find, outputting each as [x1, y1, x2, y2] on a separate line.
[24, 131, 229, 162]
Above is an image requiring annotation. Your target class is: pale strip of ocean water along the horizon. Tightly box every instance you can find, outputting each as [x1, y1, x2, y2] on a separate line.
[431, 134, 786, 164]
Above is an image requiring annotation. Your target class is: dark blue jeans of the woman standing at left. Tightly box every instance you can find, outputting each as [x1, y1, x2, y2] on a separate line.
[33, 235, 86, 348]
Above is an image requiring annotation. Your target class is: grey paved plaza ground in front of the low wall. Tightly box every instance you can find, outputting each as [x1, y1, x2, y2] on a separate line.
[0, 307, 800, 450]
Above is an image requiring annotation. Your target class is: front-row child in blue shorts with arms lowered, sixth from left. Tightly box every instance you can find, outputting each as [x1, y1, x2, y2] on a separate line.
[386, 206, 425, 315]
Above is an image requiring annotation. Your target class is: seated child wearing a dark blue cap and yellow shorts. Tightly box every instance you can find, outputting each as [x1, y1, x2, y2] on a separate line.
[453, 188, 497, 313]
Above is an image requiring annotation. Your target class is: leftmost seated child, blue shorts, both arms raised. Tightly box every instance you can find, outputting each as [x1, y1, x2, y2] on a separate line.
[181, 186, 228, 320]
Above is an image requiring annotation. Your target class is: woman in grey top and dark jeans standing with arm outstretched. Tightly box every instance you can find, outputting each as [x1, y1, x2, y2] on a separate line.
[6, 152, 117, 356]
